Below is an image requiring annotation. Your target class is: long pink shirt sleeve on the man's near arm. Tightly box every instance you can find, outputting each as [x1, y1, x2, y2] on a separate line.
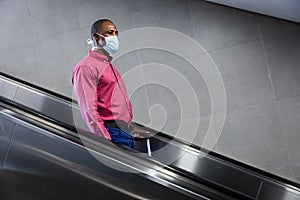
[73, 66, 111, 140]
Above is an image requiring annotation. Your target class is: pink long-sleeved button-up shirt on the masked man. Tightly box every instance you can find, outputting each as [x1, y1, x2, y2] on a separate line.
[72, 50, 132, 140]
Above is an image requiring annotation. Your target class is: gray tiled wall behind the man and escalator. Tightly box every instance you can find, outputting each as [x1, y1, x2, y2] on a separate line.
[0, 0, 300, 183]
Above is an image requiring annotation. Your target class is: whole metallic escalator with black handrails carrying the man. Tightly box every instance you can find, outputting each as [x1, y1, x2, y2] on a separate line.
[0, 73, 300, 200]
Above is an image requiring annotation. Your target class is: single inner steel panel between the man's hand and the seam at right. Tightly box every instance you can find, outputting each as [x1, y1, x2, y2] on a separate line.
[138, 138, 261, 199]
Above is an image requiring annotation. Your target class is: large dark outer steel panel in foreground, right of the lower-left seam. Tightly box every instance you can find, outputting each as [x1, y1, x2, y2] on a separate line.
[0, 113, 209, 200]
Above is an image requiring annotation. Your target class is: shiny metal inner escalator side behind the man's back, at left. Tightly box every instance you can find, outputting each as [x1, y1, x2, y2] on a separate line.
[0, 73, 79, 127]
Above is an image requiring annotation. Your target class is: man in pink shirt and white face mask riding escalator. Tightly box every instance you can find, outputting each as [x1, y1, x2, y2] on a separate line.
[72, 19, 147, 149]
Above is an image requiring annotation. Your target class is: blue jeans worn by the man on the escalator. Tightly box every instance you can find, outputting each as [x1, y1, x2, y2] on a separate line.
[106, 126, 136, 149]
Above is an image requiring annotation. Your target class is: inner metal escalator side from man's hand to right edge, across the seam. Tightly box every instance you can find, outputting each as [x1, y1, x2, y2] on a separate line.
[138, 137, 300, 200]
